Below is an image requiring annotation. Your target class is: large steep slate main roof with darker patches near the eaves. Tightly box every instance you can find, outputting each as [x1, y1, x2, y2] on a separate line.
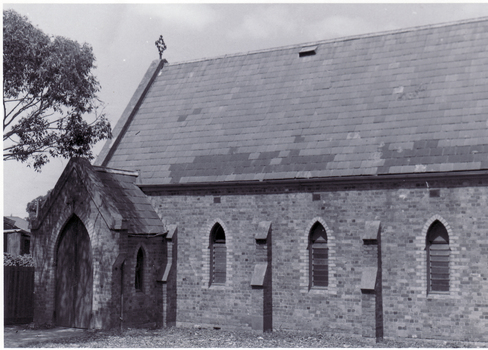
[97, 18, 488, 185]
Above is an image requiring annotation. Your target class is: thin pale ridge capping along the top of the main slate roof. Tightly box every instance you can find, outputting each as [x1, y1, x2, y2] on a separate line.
[168, 16, 488, 66]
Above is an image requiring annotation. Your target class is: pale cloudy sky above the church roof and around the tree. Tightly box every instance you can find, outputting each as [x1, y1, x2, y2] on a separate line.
[3, 2, 488, 217]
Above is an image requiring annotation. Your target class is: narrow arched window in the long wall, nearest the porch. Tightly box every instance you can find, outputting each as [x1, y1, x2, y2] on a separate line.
[210, 223, 227, 284]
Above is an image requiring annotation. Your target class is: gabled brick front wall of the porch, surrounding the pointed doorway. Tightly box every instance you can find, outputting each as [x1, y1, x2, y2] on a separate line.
[32, 171, 120, 329]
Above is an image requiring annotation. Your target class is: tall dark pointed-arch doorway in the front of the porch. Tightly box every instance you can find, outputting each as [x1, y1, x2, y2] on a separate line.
[55, 216, 93, 328]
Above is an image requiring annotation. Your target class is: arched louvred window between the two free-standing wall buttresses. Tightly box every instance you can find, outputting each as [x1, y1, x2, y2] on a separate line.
[308, 222, 329, 288]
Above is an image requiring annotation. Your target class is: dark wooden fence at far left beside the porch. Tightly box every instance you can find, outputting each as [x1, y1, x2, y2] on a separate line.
[3, 266, 34, 325]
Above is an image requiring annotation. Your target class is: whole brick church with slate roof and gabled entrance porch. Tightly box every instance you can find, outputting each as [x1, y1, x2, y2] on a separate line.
[32, 18, 488, 342]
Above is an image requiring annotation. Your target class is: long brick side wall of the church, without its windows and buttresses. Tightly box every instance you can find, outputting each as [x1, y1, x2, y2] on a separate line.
[147, 178, 488, 341]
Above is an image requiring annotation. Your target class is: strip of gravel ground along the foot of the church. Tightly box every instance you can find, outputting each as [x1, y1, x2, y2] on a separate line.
[11, 328, 488, 348]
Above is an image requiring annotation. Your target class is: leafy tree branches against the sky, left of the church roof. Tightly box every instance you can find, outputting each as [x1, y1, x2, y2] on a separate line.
[3, 10, 112, 171]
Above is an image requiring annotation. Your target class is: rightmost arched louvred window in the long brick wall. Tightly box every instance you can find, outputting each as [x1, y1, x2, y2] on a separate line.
[426, 220, 450, 292]
